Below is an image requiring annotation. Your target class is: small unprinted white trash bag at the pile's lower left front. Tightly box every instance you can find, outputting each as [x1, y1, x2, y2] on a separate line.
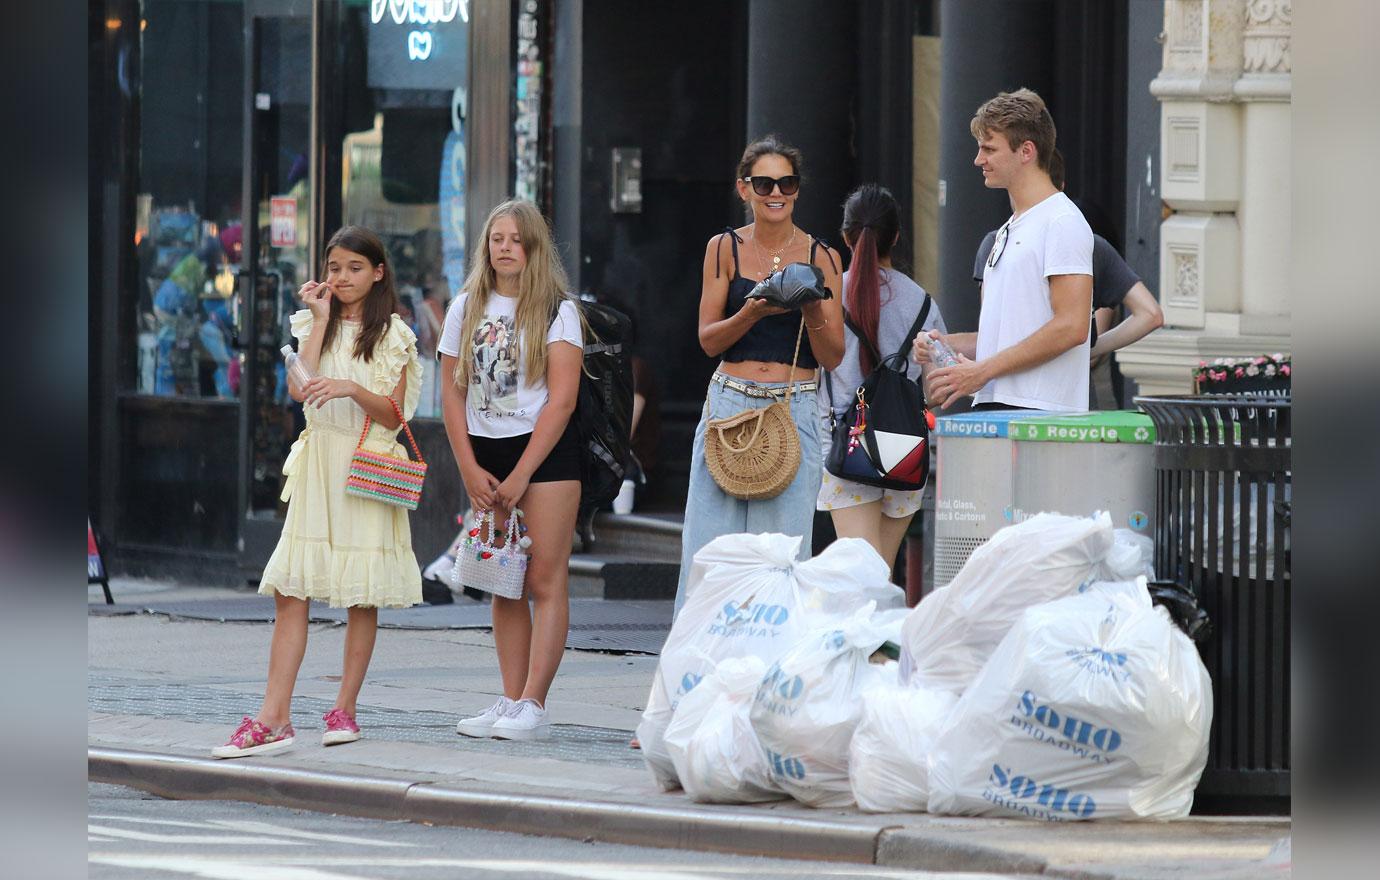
[665, 657, 785, 804]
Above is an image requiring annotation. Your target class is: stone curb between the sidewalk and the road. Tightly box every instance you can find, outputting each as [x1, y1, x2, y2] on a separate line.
[87, 748, 1047, 874]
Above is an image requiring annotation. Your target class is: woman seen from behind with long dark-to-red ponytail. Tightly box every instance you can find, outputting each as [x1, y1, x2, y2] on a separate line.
[817, 183, 947, 566]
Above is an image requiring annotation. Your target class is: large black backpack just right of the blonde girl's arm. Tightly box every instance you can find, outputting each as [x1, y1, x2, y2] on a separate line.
[552, 299, 633, 514]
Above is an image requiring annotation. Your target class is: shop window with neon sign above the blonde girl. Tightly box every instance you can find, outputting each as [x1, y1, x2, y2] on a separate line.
[339, 0, 471, 417]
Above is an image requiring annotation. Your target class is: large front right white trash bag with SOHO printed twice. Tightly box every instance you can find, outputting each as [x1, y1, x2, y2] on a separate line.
[929, 579, 1212, 822]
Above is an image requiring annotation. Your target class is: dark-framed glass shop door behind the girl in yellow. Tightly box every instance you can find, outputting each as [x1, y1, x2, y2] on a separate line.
[240, 1, 315, 572]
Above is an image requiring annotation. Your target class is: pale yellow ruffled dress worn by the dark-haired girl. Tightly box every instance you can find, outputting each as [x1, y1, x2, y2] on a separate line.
[259, 309, 422, 608]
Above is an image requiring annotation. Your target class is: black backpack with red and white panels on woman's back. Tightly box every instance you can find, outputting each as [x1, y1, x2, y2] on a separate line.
[824, 300, 930, 491]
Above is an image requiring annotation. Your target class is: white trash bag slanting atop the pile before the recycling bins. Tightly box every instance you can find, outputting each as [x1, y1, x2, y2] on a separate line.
[900, 513, 1112, 694]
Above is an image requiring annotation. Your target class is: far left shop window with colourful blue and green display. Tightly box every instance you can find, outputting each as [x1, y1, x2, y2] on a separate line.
[134, 0, 244, 399]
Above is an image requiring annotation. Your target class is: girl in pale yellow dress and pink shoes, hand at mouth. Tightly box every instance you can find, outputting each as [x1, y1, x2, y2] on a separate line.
[211, 226, 422, 757]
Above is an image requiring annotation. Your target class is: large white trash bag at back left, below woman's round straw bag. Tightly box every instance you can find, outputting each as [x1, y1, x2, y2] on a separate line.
[638, 534, 904, 790]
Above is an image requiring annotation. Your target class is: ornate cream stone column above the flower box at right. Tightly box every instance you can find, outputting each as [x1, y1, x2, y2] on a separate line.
[1116, 0, 1292, 394]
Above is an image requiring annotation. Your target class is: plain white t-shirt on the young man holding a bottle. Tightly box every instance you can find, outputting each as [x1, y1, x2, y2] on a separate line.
[973, 193, 1093, 412]
